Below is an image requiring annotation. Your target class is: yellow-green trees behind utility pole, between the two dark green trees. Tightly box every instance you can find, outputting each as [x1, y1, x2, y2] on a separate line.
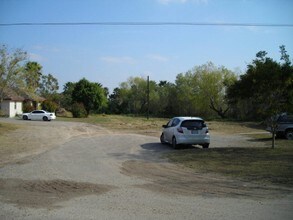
[109, 63, 236, 118]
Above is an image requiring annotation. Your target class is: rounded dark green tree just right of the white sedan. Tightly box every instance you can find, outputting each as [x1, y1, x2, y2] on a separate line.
[72, 78, 107, 115]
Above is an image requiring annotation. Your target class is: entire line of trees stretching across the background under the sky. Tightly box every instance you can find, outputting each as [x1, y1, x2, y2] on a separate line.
[0, 46, 293, 120]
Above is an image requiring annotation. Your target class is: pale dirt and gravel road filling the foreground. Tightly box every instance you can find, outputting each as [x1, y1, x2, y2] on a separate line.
[0, 119, 293, 220]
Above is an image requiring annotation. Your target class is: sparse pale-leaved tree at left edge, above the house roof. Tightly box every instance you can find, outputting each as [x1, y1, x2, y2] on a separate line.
[0, 45, 27, 102]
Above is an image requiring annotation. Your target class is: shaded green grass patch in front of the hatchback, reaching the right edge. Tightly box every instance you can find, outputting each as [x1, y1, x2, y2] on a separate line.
[167, 146, 293, 186]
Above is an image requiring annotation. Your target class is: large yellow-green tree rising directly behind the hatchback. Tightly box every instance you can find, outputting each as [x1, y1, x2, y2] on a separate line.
[175, 62, 236, 118]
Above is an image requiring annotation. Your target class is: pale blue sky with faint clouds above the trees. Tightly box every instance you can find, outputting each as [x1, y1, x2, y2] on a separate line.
[0, 0, 293, 91]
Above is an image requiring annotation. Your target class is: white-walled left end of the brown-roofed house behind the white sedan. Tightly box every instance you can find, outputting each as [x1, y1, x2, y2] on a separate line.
[0, 90, 24, 118]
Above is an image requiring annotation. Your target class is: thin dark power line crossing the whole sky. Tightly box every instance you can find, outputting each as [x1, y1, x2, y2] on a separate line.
[0, 22, 293, 27]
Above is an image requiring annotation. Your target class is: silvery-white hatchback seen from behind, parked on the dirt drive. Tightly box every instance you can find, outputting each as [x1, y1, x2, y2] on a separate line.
[160, 117, 210, 148]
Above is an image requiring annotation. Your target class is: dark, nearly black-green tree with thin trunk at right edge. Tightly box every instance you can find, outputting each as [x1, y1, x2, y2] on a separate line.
[227, 46, 293, 148]
